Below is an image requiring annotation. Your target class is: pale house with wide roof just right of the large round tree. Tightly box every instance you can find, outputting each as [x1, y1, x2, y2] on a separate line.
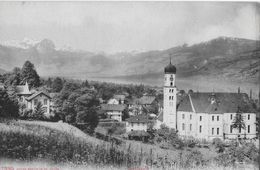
[101, 104, 126, 122]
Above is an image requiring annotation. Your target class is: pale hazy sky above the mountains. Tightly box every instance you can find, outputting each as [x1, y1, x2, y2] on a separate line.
[0, 2, 260, 53]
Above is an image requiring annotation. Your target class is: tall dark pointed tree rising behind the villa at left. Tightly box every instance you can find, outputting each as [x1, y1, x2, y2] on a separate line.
[21, 61, 40, 87]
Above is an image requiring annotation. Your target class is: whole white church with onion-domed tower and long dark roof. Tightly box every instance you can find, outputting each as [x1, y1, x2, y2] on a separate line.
[158, 61, 257, 140]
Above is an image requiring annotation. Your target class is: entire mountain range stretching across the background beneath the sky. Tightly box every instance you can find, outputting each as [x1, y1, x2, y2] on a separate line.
[0, 37, 260, 95]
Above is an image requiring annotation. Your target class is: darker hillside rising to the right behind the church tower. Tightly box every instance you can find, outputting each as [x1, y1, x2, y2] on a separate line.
[108, 37, 260, 82]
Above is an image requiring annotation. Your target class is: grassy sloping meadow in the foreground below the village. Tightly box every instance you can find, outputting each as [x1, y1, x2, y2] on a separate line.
[0, 120, 256, 170]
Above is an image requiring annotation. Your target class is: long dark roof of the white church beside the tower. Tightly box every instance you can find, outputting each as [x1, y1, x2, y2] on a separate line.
[178, 92, 256, 113]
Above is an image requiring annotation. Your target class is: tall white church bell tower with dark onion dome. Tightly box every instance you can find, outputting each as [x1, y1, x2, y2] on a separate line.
[163, 60, 177, 130]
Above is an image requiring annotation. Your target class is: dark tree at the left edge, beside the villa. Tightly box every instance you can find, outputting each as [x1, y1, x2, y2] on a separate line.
[0, 89, 19, 117]
